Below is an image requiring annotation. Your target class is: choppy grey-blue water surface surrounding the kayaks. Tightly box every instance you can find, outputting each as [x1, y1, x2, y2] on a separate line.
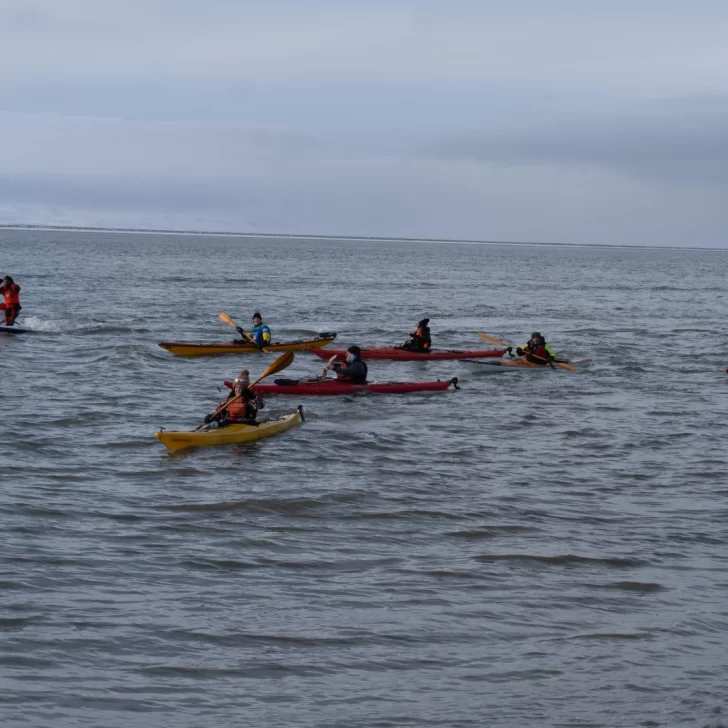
[0, 231, 728, 728]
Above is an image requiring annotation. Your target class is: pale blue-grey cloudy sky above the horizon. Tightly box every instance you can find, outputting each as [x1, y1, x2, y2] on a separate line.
[0, 0, 728, 247]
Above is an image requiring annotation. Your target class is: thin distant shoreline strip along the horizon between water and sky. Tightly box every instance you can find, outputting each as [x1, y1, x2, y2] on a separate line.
[0, 223, 728, 252]
